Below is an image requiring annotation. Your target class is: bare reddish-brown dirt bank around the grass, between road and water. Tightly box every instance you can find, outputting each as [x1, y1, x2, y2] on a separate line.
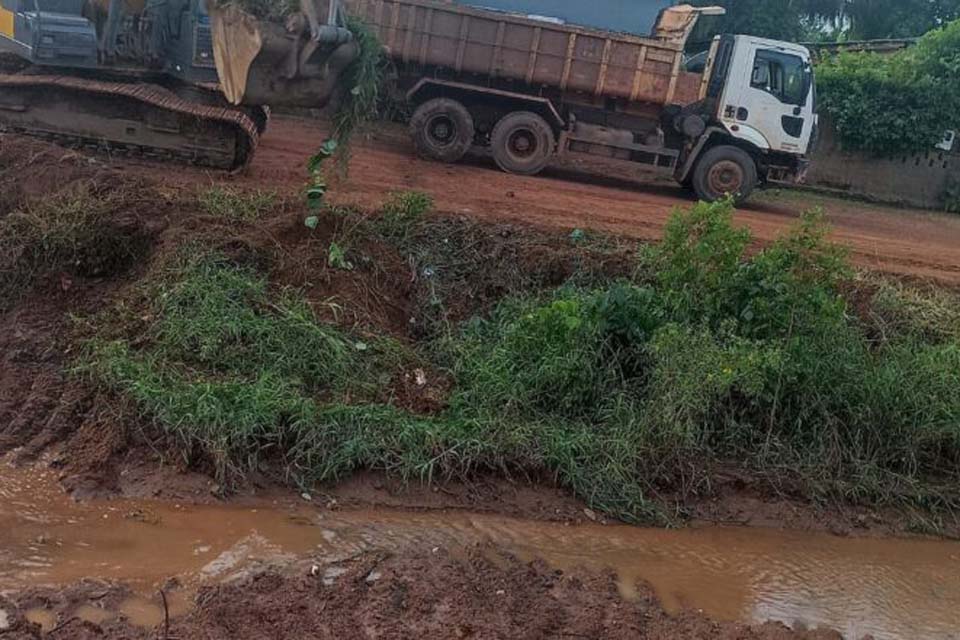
[0, 131, 950, 535]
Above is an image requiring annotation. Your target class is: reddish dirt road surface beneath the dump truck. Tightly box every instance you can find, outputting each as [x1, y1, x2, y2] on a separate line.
[242, 118, 960, 286]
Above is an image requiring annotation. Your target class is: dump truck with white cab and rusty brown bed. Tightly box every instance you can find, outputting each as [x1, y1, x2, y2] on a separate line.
[348, 0, 817, 201]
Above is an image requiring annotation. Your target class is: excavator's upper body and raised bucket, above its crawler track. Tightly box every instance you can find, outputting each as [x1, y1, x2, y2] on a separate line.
[0, 0, 357, 108]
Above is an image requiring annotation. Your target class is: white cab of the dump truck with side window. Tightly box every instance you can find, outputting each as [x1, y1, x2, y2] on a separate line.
[720, 37, 816, 154]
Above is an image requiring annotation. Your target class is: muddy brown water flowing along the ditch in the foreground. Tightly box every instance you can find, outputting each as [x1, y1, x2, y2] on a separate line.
[0, 466, 960, 640]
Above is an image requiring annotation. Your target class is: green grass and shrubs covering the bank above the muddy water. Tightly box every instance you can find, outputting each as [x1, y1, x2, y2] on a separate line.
[82, 195, 960, 521]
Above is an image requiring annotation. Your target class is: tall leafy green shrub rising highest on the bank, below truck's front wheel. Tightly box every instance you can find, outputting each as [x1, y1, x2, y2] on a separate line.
[649, 201, 849, 338]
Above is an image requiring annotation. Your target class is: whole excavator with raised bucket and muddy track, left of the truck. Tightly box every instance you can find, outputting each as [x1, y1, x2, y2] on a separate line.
[0, 0, 358, 170]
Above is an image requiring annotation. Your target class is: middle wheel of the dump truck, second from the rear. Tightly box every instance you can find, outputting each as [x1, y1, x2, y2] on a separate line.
[490, 111, 557, 176]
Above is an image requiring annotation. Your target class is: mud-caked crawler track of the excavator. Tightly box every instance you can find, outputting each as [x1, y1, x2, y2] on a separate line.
[0, 73, 260, 170]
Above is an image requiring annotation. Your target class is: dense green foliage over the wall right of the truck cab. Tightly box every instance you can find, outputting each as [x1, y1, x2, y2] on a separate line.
[817, 20, 960, 156]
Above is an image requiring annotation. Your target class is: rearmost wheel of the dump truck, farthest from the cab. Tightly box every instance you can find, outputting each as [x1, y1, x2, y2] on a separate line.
[410, 98, 476, 162]
